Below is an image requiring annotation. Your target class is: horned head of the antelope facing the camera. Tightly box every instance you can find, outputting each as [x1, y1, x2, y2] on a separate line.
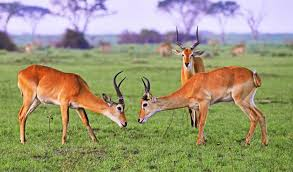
[173, 27, 203, 69]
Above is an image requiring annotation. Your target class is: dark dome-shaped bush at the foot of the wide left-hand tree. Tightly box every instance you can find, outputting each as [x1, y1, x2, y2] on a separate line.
[58, 29, 92, 49]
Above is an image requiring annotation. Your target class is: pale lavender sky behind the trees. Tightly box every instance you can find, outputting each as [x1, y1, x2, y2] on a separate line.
[0, 0, 293, 35]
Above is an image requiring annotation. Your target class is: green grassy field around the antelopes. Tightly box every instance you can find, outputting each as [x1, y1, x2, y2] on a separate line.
[0, 45, 293, 171]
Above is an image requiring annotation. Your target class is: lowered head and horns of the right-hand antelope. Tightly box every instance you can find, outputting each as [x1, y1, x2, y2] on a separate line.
[138, 77, 161, 124]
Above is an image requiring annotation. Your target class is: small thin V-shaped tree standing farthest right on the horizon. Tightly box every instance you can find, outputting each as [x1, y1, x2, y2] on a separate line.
[243, 9, 265, 40]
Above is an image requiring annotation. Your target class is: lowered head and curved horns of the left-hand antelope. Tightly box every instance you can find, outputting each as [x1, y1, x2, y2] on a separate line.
[102, 71, 127, 127]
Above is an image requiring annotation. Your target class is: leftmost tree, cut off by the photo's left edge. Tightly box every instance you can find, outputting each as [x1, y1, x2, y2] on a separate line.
[0, 2, 22, 32]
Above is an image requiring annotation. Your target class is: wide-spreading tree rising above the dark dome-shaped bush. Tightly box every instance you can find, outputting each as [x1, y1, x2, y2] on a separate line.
[51, 0, 113, 33]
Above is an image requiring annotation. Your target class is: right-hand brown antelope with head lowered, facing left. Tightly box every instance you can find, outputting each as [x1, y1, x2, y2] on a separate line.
[138, 66, 268, 145]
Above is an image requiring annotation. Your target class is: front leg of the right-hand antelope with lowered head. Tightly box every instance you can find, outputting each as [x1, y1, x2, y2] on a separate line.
[196, 102, 208, 145]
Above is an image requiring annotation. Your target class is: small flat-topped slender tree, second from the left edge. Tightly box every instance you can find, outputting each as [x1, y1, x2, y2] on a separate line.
[19, 5, 51, 40]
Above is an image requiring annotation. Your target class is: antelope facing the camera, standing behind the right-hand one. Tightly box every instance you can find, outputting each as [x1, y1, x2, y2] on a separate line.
[174, 27, 205, 127]
